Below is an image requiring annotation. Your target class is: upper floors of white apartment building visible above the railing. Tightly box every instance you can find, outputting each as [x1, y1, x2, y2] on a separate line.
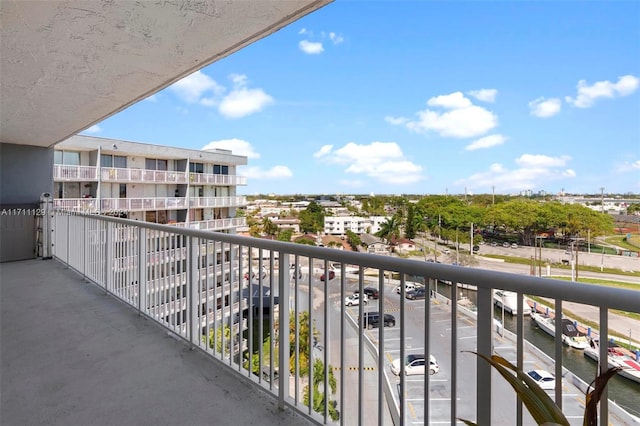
[53, 135, 247, 233]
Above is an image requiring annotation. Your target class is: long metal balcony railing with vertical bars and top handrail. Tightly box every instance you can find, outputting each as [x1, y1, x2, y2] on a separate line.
[53, 212, 640, 425]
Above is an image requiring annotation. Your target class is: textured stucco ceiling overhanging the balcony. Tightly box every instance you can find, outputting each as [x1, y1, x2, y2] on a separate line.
[0, 0, 332, 146]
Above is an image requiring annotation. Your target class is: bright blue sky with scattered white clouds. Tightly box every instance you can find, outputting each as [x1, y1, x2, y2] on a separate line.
[84, 0, 640, 194]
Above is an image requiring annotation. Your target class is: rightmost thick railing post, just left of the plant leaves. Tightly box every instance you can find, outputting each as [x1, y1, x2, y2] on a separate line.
[478, 282, 492, 426]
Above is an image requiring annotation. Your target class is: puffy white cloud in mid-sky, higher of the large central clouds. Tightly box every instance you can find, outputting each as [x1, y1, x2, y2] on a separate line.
[394, 92, 498, 138]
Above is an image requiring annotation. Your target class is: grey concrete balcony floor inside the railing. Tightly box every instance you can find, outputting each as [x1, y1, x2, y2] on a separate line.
[0, 259, 312, 426]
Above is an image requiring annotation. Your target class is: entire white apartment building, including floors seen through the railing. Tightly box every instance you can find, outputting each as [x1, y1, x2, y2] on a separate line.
[53, 136, 247, 349]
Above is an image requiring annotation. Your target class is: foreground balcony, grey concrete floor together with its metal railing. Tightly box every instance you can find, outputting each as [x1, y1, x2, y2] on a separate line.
[2, 213, 640, 425]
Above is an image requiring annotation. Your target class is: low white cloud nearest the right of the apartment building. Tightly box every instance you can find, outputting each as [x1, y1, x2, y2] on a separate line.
[314, 142, 423, 184]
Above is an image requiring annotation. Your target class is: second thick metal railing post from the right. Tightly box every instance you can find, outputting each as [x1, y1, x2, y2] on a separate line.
[278, 253, 292, 410]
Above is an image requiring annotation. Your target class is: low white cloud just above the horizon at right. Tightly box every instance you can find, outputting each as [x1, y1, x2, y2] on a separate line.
[455, 154, 576, 192]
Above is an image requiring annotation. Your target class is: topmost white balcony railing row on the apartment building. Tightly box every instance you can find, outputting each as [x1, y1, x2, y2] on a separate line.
[53, 164, 247, 186]
